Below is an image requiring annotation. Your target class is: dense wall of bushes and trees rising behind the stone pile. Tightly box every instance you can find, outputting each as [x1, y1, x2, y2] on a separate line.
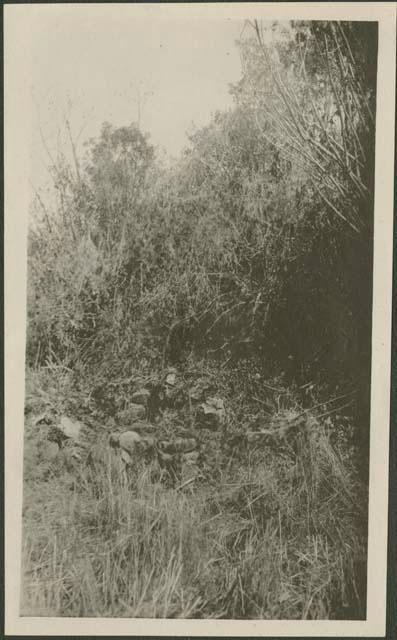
[28, 22, 376, 396]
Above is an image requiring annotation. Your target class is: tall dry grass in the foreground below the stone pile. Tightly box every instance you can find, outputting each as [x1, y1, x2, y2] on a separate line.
[21, 370, 366, 619]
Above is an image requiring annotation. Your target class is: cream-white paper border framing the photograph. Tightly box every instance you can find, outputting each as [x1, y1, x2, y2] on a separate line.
[4, 2, 396, 637]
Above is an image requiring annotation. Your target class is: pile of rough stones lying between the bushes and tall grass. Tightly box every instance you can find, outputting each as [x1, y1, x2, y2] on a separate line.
[36, 369, 225, 488]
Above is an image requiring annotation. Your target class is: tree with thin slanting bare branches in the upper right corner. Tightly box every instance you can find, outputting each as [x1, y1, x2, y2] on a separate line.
[239, 21, 377, 233]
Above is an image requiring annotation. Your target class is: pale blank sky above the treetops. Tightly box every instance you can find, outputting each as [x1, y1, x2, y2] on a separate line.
[25, 5, 244, 187]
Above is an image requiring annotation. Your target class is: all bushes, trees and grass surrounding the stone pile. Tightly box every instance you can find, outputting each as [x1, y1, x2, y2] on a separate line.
[25, 22, 377, 618]
